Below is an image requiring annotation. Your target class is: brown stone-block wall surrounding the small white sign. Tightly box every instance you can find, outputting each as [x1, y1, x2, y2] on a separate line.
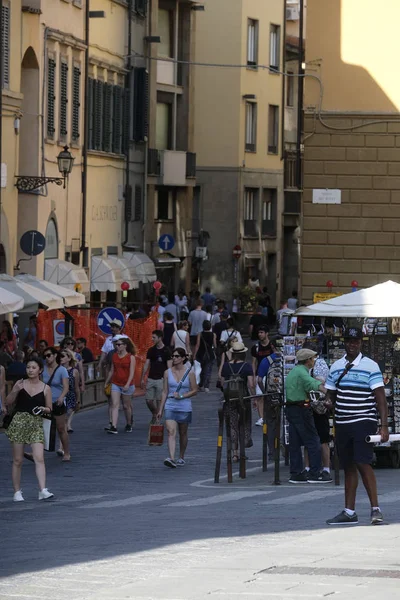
[301, 114, 400, 303]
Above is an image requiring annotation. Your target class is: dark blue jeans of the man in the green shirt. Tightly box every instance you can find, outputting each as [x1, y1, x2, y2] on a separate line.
[286, 403, 322, 475]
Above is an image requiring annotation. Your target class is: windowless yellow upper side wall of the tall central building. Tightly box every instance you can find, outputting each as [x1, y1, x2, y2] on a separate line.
[193, 0, 243, 167]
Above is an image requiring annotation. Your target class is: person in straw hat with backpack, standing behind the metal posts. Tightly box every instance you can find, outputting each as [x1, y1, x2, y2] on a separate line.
[221, 342, 255, 462]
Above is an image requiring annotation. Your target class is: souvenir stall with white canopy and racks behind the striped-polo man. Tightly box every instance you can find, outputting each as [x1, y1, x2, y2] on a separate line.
[284, 281, 400, 468]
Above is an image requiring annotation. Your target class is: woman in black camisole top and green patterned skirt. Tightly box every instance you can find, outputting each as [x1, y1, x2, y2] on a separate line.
[5, 358, 54, 502]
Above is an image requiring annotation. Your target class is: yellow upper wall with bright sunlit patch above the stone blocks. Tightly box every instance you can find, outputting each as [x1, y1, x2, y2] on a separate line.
[305, 0, 400, 112]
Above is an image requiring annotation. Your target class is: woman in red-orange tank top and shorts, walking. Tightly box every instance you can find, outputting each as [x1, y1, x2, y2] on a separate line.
[104, 335, 136, 434]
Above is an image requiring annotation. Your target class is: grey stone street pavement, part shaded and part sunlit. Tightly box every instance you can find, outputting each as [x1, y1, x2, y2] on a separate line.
[0, 384, 400, 600]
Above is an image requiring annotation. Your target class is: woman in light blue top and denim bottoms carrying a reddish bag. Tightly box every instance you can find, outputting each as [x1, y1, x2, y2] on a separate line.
[157, 348, 197, 469]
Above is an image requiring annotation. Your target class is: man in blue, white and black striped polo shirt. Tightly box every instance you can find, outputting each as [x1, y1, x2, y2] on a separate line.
[325, 328, 389, 525]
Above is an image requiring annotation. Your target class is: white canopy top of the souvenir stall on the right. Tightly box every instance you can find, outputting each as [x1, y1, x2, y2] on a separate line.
[295, 281, 400, 318]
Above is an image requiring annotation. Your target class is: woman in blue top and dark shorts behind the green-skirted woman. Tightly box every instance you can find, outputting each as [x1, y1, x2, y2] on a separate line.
[42, 347, 71, 462]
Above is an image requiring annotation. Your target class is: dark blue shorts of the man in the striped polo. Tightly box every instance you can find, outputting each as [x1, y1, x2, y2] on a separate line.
[335, 421, 378, 468]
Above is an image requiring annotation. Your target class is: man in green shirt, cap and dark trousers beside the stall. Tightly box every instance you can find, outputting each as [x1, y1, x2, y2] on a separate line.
[285, 348, 332, 483]
